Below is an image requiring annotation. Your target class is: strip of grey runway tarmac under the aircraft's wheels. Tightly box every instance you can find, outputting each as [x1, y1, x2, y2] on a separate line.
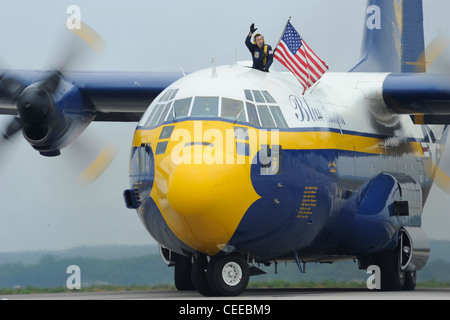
[0, 288, 450, 301]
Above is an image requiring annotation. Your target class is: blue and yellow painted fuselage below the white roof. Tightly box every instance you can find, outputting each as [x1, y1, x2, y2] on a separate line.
[125, 70, 440, 261]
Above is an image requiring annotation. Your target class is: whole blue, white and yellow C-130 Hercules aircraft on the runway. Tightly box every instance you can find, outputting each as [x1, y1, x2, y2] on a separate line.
[0, 0, 450, 296]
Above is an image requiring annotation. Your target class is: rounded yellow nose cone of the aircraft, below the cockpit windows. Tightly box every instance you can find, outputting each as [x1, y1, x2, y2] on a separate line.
[152, 145, 259, 255]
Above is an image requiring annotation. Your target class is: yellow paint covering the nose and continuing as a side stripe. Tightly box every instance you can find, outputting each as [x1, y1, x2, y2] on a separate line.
[133, 120, 423, 255]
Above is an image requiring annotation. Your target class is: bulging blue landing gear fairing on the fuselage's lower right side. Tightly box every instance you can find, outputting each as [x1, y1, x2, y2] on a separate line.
[341, 173, 422, 255]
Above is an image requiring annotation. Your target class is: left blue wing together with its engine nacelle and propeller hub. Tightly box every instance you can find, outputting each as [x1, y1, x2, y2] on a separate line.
[0, 70, 182, 156]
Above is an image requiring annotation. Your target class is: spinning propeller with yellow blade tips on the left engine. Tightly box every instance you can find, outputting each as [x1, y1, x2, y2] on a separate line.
[0, 21, 116, 185]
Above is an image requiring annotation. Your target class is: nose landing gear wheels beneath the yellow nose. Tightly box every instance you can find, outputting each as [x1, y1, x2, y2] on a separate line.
[175, 253, 250, 296]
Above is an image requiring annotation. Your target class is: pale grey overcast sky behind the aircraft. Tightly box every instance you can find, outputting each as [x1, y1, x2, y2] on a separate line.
[0, 0, 450, 252]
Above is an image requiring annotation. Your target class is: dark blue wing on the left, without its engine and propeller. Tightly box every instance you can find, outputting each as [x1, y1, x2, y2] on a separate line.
[0, 70, 183, 122]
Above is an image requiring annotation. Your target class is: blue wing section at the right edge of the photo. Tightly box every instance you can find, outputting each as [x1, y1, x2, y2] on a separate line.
[383, 73, 450, 124]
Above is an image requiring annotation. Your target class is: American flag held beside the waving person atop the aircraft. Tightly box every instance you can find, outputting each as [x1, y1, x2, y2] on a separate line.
[274, 21, 328, 92]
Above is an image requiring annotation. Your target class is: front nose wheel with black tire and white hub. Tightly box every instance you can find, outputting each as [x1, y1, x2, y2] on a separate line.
[206, 254, 250, 296]
